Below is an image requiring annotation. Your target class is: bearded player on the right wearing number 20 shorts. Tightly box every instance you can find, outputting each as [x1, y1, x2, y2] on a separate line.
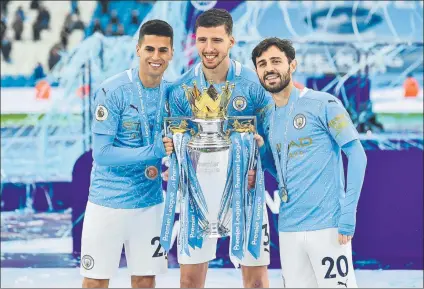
[252, 38, 367, 288]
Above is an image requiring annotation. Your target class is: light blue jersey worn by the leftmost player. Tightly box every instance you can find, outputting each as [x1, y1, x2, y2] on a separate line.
[89, 69, 168, 209]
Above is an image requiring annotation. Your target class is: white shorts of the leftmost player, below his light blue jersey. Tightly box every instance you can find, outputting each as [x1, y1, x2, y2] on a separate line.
[80, 202, 168, 279]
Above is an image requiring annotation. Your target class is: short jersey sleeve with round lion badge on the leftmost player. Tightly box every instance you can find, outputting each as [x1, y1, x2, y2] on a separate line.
[92, 88, 121, 135]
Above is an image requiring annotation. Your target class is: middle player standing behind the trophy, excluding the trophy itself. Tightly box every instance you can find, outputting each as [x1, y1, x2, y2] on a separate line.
[169, 9, 272, 288]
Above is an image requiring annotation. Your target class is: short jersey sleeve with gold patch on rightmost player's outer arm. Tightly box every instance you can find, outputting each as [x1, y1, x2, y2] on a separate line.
[320, 97, 359, 147]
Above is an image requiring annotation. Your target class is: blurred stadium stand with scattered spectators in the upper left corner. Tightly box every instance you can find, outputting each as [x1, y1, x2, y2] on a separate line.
[1, 0, 154, 87]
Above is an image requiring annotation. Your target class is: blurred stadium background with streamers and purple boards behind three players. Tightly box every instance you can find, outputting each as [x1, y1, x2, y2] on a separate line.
[0, 0, 423, 288]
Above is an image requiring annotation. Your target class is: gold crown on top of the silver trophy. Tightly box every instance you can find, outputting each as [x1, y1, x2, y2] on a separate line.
[183, 81, 235, 119]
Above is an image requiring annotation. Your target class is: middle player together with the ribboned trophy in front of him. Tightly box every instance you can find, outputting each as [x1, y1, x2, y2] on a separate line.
[161, 9, 272, 288]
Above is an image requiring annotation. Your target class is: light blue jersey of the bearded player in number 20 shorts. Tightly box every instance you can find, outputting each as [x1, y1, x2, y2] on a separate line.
[268, 87, 362, 234]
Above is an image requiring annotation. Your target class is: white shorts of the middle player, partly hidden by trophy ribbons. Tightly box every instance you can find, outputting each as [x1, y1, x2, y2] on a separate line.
[177, 204, 271, 267]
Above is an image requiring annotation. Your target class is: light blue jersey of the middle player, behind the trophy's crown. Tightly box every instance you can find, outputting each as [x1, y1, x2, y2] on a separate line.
[169, 60, 273, 134]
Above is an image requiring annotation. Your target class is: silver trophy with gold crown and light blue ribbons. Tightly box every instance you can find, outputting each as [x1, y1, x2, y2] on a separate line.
[161, 81, 265, 259]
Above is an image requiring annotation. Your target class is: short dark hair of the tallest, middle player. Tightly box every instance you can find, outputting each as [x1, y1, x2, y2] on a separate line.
[194, 8, 233, 35]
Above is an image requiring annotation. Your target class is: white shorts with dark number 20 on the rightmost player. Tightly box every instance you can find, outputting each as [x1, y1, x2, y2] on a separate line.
[279, 228, 358, 288]
